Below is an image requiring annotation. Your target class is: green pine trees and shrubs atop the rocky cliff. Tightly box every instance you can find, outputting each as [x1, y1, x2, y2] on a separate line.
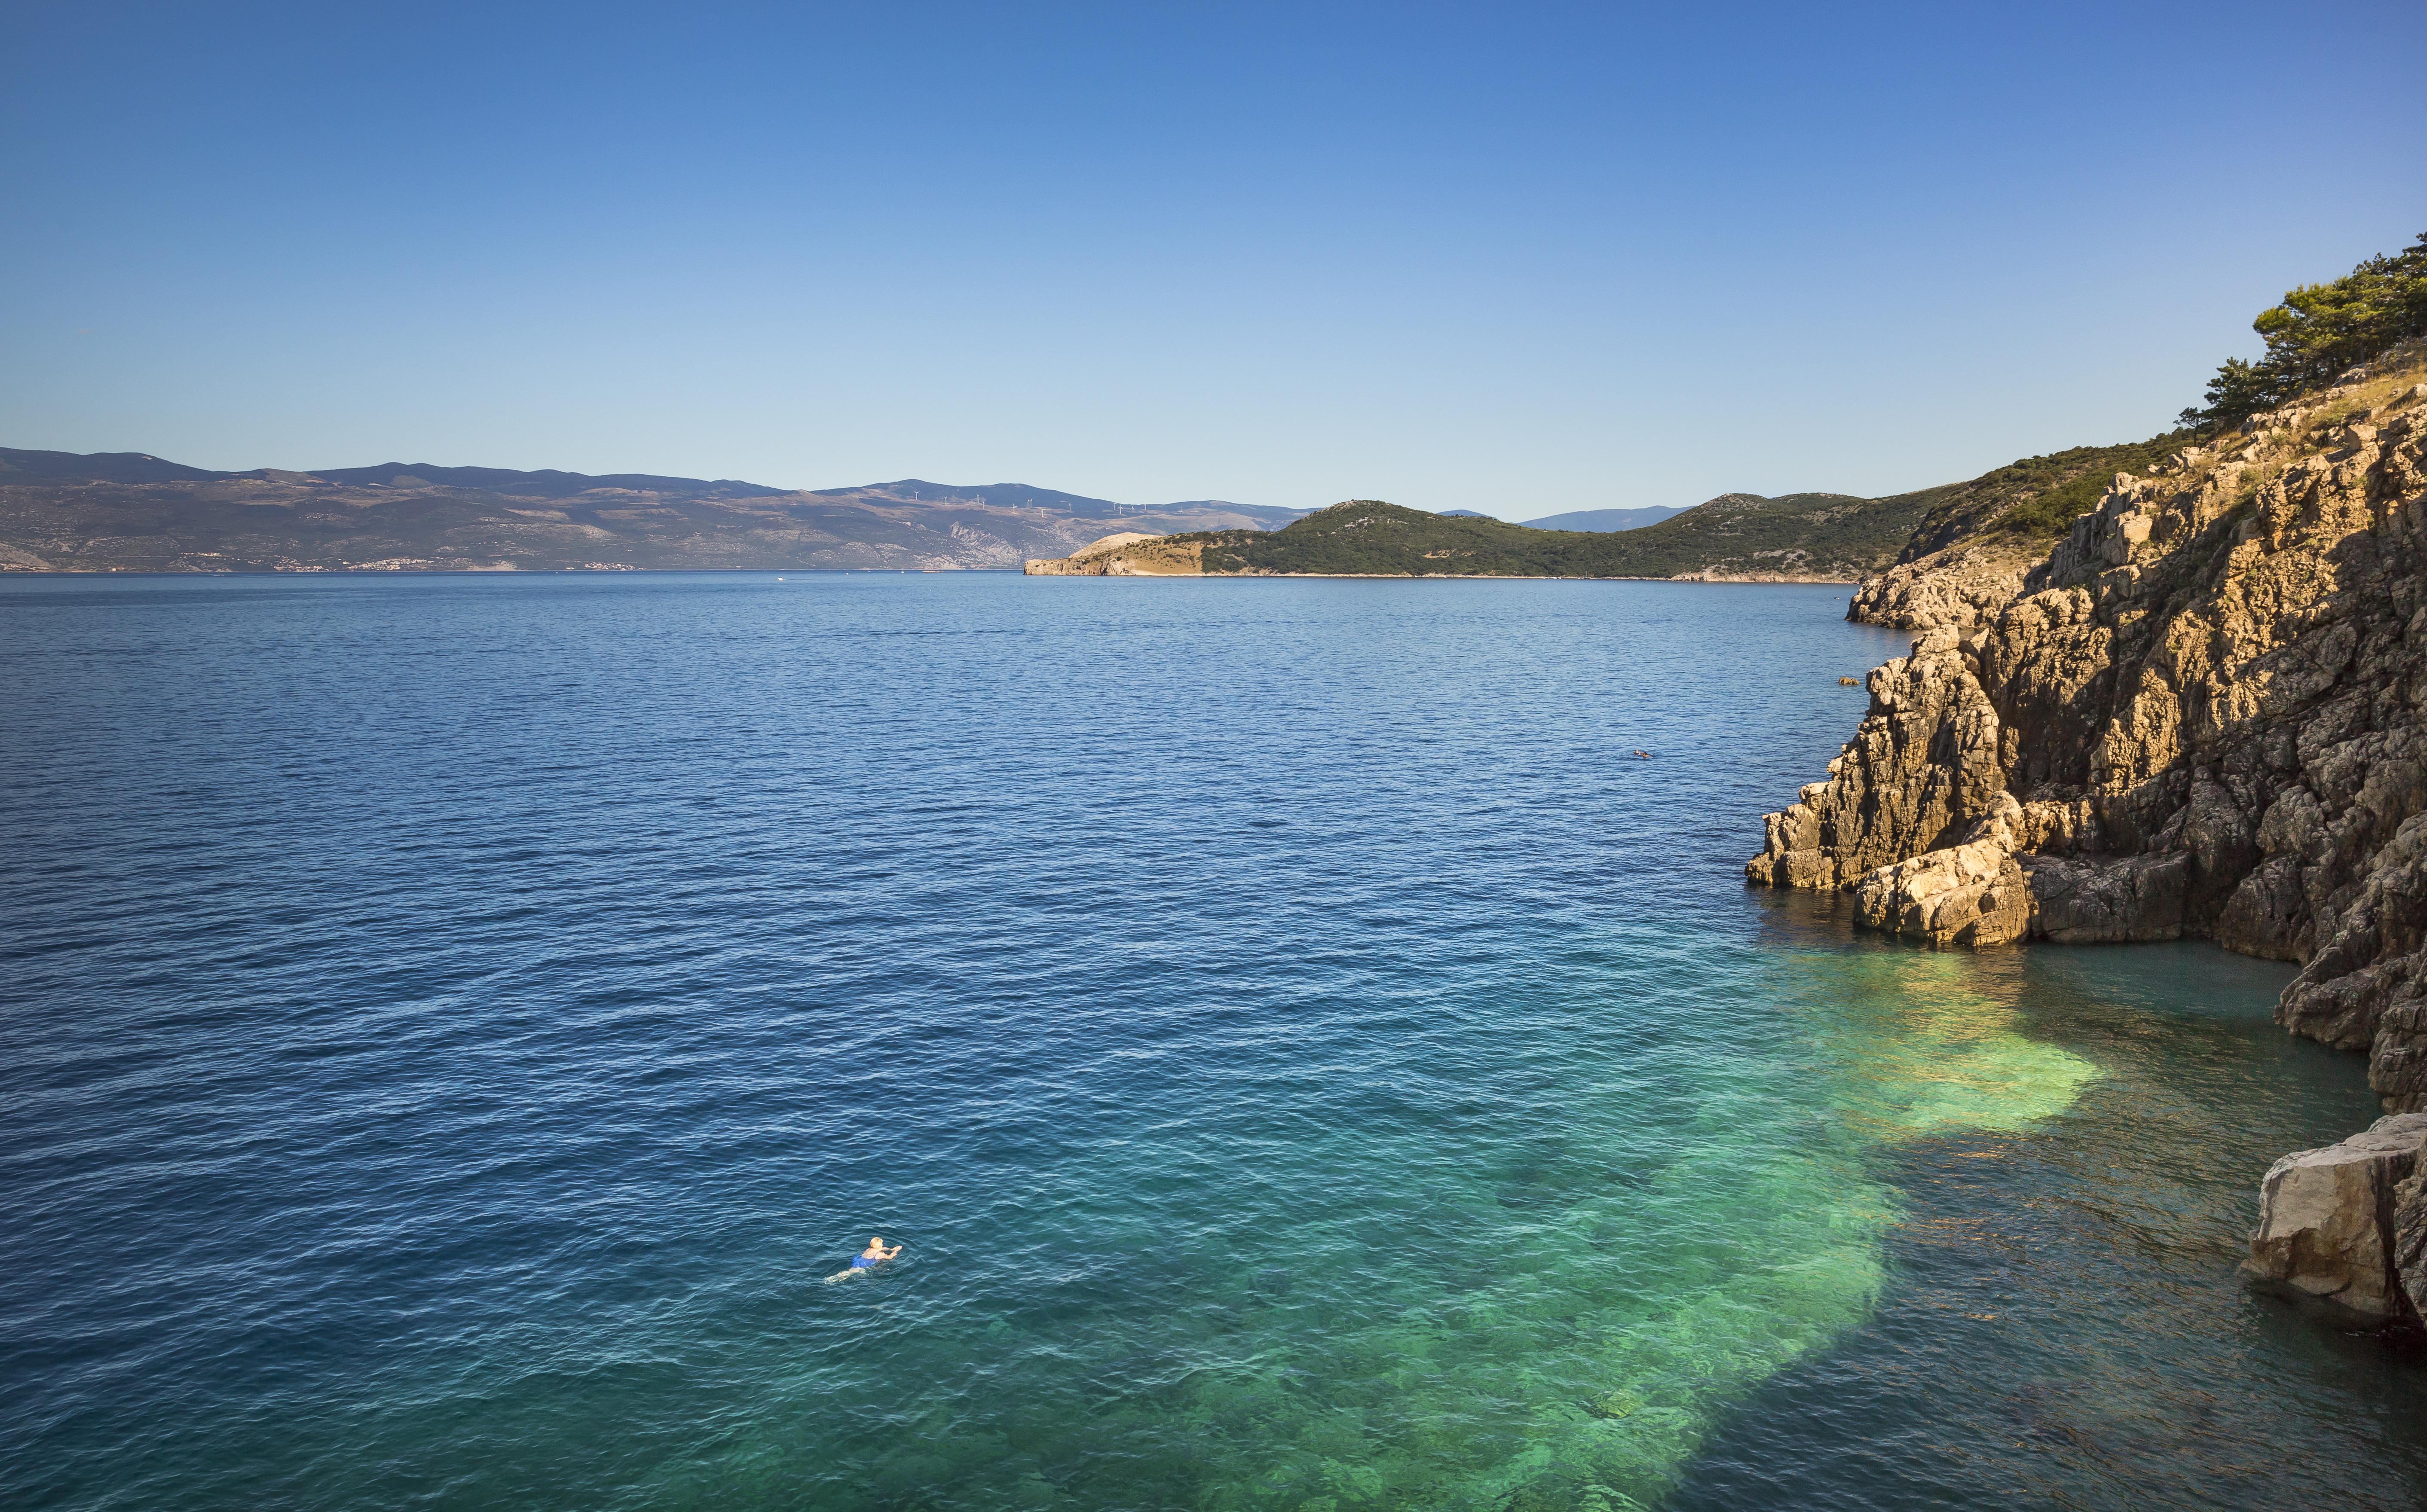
[2182, 233, 2427, 432]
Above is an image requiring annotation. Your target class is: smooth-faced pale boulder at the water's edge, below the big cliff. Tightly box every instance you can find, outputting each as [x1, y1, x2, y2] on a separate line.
[2243, 1114, 2427, 1318]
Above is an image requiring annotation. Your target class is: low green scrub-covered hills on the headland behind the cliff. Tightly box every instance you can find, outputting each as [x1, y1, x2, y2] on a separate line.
[1177, 488, 1944, 580]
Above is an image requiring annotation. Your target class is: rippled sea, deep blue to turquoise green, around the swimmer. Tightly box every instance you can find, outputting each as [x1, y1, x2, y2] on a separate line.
[0, 575, 2427, 1509]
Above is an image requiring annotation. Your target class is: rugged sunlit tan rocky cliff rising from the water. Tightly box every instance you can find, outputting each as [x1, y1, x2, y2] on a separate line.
[1745, 345, 2427, 1310]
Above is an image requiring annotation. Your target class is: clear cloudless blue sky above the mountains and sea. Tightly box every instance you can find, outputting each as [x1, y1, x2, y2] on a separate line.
[0, 3, 2427, 519]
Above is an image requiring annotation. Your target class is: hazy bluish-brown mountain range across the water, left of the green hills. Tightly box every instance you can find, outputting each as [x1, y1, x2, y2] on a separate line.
[0, 446, 1303, 573]
